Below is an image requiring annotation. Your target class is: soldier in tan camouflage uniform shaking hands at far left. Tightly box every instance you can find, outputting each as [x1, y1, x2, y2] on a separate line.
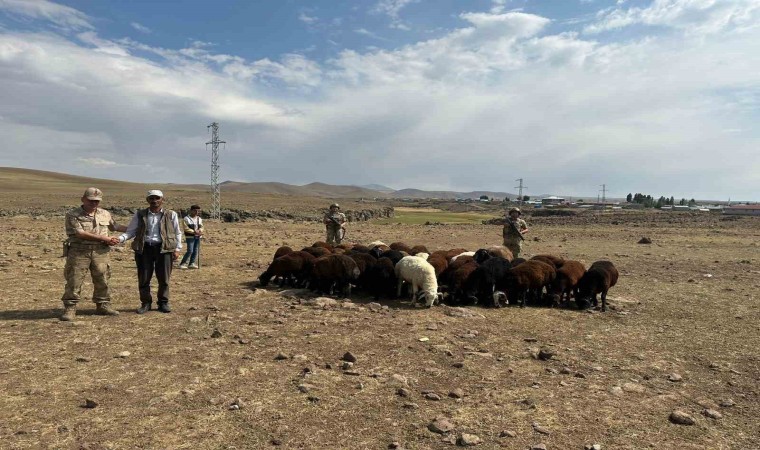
[61, 188, 126, 321]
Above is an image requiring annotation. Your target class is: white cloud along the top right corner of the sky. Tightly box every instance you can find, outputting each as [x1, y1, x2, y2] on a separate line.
[584, 0, 760, 34]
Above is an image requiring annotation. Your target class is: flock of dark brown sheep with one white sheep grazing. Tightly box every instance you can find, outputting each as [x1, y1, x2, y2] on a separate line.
[259, 241, 618, 311]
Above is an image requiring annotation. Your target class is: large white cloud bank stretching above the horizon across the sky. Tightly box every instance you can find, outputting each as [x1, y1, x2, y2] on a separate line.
[0, 2, 760, 199]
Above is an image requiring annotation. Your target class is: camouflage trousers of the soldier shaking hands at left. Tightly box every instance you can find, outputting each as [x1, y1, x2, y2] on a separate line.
[61, 245, 111, 306]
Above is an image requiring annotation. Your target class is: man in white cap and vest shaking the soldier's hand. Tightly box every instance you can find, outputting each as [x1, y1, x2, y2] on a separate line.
[119, 189, 182, 314]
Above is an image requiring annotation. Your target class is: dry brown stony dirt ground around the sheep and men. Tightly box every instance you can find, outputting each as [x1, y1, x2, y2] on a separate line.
[0, 206, 760, 449]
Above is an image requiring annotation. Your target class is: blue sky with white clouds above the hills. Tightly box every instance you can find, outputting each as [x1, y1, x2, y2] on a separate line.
[0, 0, 760, 201]
